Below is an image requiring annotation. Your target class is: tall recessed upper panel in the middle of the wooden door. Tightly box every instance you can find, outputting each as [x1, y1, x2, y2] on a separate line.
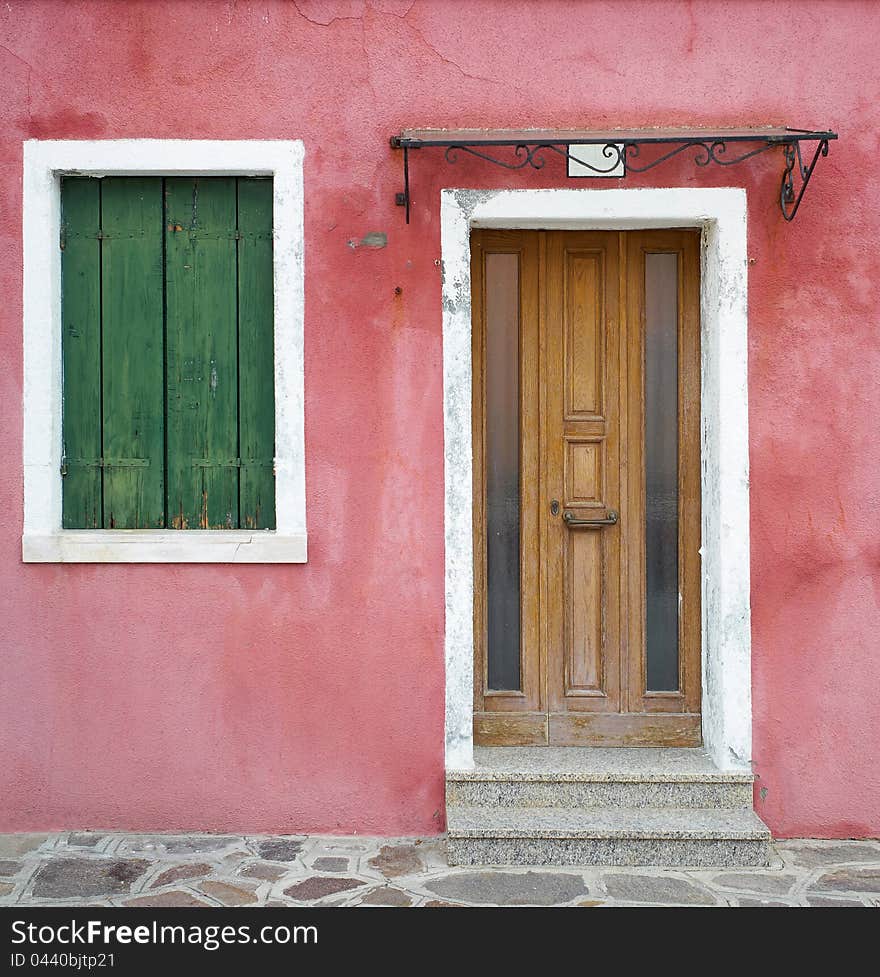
[564, 254, 614, 418]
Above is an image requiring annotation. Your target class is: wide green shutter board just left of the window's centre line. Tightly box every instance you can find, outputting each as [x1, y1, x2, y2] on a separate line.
[101, 177, 165, 529]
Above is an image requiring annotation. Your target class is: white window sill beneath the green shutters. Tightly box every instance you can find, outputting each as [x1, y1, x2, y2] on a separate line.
[21, 529, 308, 563]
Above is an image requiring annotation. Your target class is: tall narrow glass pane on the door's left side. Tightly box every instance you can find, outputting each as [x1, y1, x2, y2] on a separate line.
[485, 254, 520, 691]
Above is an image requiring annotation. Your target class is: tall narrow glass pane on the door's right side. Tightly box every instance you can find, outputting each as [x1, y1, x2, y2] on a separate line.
[645, 254, 679, 692]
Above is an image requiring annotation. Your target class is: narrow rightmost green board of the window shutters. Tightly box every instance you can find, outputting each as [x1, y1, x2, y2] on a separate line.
[238, 177, 275, 529]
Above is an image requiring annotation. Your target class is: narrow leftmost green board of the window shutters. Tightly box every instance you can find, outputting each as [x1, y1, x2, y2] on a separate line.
[60, 177, 103, 529]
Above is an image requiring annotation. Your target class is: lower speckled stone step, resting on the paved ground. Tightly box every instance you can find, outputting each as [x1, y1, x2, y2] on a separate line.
[447, 805, 770, 867]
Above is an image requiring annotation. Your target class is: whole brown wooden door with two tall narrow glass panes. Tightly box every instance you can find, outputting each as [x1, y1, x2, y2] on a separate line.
[472, 230, 700, 746]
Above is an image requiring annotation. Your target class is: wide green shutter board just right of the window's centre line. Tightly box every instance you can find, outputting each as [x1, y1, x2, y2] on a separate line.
[165, 177, 239, 529]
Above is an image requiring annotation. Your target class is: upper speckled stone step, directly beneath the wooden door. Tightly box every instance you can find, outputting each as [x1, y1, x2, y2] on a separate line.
[446, 747, 753, 810]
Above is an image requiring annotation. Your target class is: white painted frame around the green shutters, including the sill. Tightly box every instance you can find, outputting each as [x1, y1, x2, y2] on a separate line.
[22, 139, 307, 563]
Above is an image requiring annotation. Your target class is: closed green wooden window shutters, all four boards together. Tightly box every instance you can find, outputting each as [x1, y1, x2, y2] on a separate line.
[62, 177, 275, 529]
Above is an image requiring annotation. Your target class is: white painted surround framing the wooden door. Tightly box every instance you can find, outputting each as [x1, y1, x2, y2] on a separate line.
[440, 187, 752, 770]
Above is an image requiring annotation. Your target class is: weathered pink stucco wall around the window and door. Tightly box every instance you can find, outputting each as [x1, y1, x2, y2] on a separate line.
[0, 0, 880, 836]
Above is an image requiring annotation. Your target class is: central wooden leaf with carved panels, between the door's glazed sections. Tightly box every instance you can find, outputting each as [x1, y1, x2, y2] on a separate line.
[542, 232, 621, 712]
